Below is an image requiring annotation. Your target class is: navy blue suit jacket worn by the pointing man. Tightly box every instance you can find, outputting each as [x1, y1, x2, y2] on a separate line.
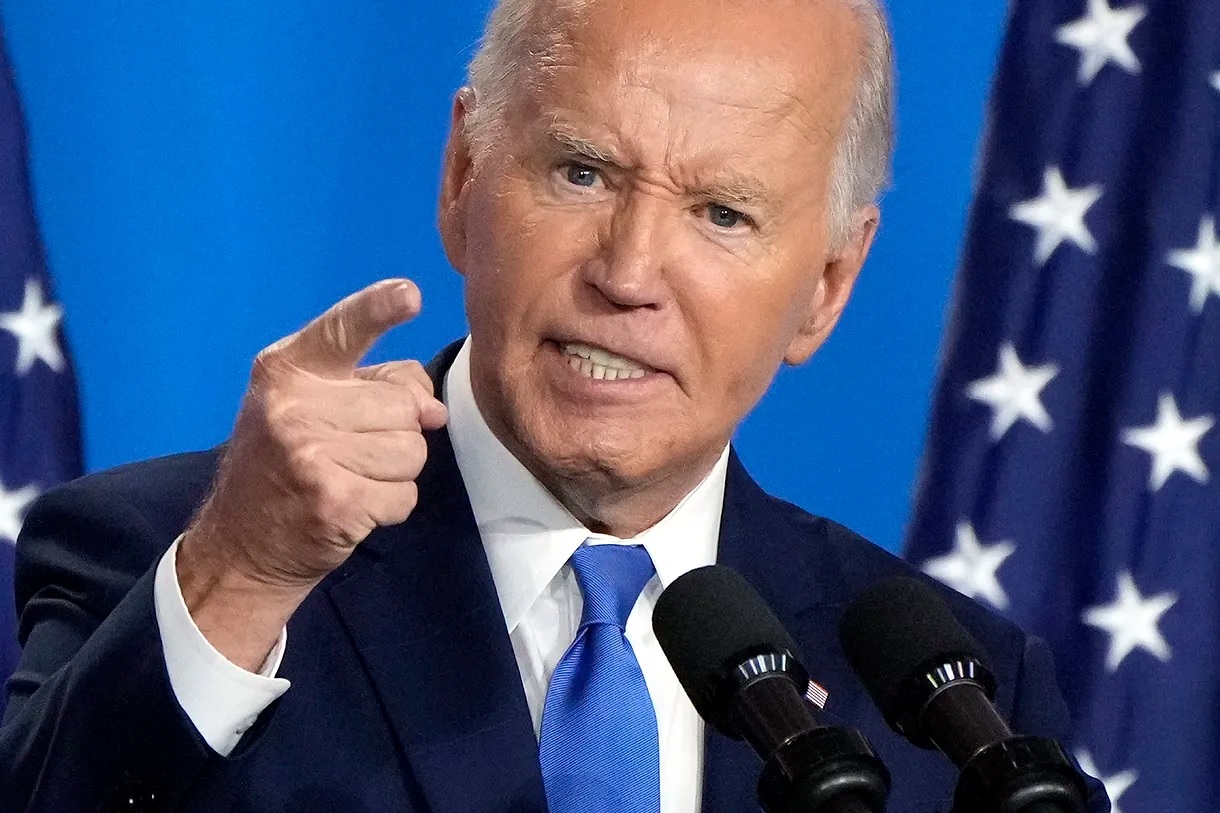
[0, 348, 1107, 813]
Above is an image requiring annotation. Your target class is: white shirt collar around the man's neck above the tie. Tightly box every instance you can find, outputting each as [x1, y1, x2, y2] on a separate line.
[444, 338, 728, 632]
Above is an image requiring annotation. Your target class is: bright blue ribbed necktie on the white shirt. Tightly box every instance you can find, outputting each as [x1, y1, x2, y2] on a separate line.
[540, 544, 661, 813]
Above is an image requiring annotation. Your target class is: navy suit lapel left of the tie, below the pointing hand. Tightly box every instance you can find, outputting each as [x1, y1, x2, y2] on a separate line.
[328, 344, 545, 813]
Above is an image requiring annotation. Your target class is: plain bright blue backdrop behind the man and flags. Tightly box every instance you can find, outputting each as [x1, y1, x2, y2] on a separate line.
[2, 0, 1004, 549]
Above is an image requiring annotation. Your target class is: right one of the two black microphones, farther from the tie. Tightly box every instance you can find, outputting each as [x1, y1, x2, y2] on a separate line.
[839, 577, 1086, 813]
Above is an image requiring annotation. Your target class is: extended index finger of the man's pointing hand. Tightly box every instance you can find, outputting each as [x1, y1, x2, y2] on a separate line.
[268, 280, 422, 377]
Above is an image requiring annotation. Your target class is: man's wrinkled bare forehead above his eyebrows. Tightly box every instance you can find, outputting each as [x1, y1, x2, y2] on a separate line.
[522, 0, 863, 140]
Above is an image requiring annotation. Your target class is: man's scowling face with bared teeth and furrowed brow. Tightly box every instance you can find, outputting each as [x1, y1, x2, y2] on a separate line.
[442, 0, 875, 521]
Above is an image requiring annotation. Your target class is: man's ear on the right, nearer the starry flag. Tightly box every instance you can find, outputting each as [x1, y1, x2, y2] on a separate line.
[783, 205, 881, 366]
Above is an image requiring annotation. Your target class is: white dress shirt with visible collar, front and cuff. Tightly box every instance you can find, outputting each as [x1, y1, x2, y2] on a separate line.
[155, 339, 728, 813]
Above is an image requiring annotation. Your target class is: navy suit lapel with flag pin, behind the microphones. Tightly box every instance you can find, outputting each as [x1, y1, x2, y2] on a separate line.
[703, 452, 860, 813]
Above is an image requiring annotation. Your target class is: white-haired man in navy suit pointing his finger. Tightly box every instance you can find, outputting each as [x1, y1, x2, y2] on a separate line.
[0, 0, 1102, 813]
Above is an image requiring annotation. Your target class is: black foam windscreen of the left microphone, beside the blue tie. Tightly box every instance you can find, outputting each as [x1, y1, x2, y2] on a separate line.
[653, 565, 804, 732]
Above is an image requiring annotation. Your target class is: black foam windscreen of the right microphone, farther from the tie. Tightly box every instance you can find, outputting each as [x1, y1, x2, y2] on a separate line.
[839, 576, 987, 725]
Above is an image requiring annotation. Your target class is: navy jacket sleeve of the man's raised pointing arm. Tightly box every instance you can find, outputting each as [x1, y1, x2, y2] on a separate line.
[0, 486, 218, 813]
